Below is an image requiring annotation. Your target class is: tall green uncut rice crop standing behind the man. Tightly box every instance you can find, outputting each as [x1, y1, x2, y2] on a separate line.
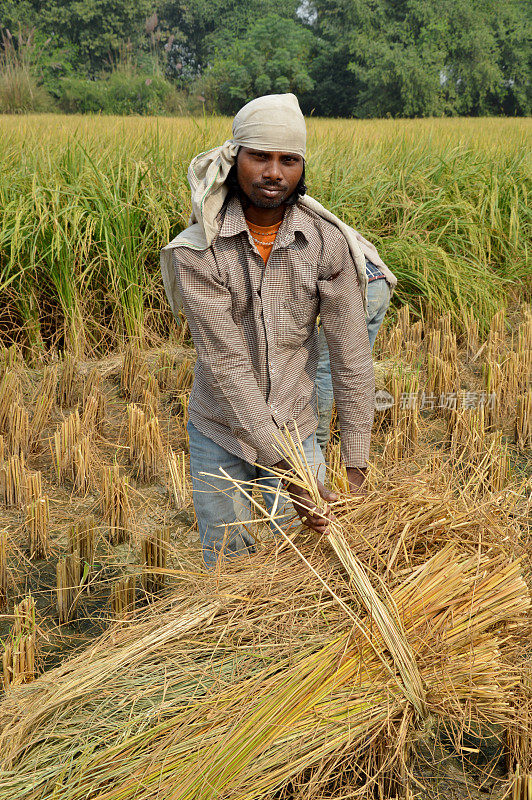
[0, 115, 532, 352]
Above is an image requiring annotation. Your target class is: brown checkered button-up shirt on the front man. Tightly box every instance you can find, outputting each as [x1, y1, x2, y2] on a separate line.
[174, 197, 375, 467]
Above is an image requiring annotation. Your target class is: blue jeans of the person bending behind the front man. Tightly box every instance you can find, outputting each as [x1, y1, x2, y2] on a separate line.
[316, 278, 390, 453]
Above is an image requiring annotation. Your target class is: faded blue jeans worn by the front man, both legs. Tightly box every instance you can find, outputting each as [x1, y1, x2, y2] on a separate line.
[187, 422, 325, 569]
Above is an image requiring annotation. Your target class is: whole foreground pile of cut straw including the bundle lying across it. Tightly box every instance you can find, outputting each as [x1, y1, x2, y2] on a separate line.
[0, 444, 530, 800]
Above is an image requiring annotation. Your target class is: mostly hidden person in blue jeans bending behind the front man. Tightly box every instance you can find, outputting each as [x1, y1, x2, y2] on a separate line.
[316, 258, 397, 455]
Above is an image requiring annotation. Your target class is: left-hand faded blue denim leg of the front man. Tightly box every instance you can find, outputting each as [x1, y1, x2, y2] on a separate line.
[187, 422, 256, 569]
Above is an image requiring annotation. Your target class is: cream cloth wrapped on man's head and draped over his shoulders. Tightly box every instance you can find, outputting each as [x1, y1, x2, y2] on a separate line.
[161, 94, 397, 316]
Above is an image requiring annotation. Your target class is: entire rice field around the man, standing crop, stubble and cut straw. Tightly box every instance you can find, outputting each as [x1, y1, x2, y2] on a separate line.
[0, 117, 532, 800]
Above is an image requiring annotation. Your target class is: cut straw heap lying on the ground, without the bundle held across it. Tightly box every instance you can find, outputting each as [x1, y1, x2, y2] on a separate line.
[0, 547, 529, 800]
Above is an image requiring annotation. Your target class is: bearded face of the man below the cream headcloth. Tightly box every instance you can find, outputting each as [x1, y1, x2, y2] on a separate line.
[236, 147, 304, 208]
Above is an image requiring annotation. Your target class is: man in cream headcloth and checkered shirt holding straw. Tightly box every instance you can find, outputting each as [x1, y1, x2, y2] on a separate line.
[161, 94, 375, 568]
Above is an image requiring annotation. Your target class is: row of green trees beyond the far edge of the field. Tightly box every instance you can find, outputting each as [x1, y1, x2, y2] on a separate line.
[0, 0, 532, 117]
